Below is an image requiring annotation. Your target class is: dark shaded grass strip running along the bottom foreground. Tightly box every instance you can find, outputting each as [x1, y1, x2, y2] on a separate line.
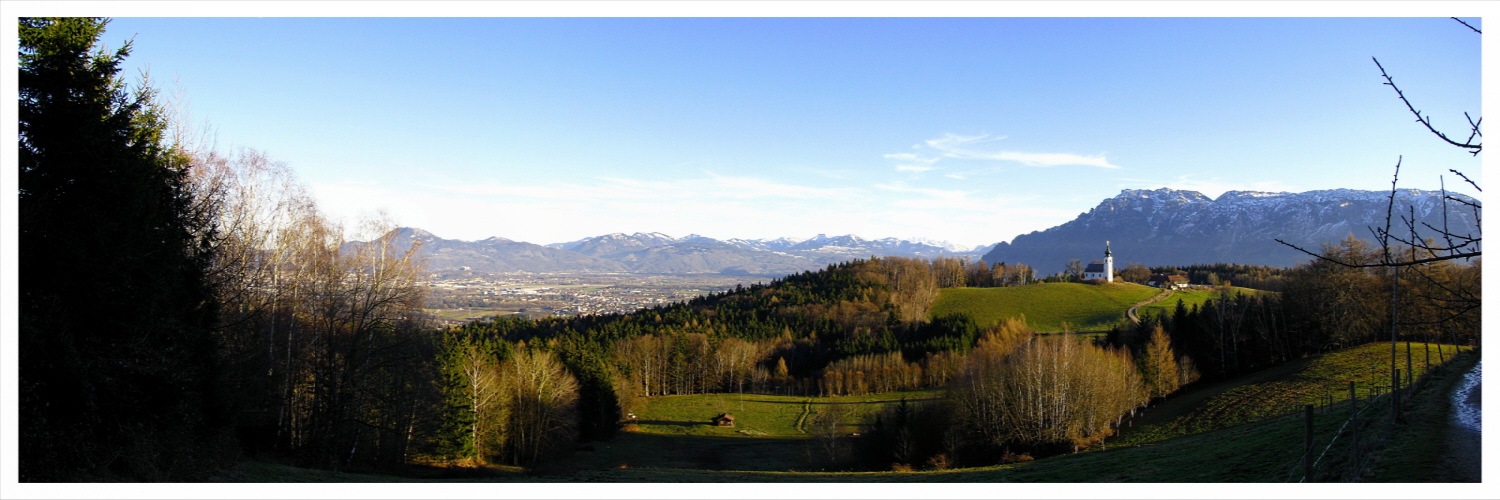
[208, 393, 1362, 483]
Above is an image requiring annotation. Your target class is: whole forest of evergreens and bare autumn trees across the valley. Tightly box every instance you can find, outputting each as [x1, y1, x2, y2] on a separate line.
[18, 18, 1481, 482]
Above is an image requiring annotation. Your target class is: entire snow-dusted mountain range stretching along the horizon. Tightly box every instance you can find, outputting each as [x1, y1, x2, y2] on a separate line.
[375, 188, 1479, 275]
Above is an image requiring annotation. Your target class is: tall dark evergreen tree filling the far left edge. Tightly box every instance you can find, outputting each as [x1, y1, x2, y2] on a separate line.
[18, 18, 230, 480]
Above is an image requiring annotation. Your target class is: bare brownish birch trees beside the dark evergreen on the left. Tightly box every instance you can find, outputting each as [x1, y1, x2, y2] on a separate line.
[189, 150, 432, 467]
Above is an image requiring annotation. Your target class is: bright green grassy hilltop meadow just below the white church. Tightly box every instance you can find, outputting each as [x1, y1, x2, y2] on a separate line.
[932, 282, 1170, 333]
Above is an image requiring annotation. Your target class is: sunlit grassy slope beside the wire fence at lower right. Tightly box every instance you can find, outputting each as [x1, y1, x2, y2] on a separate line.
[1110, 342, 1469, 446]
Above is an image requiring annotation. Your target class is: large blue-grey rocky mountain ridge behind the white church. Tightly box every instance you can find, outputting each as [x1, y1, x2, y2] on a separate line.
[984, 188, 1479, 273]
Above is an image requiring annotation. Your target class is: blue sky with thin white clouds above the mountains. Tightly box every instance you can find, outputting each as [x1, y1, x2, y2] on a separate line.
[76, 9, 1484, 246]
